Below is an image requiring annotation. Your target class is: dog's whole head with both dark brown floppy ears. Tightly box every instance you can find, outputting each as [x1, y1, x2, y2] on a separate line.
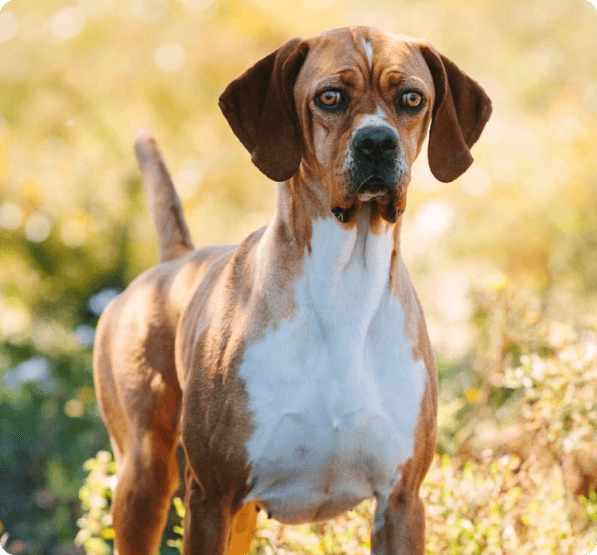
[220, 27, 491, 222]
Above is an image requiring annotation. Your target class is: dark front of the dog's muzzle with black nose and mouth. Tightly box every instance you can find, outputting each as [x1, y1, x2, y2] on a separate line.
[349, 125, 400, 200]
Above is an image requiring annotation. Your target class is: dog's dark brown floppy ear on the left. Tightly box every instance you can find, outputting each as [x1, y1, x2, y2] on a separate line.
[219, 38, 308, 181]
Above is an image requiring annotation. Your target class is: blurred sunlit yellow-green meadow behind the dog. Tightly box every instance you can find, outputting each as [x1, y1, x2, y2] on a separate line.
[0, 0, 597, 555]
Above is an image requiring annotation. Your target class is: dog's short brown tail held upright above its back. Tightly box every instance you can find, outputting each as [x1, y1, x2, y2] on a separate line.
[135, 129, 194, 262]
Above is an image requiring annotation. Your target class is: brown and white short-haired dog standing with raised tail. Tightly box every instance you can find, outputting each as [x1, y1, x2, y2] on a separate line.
[94, 27, 491, 555]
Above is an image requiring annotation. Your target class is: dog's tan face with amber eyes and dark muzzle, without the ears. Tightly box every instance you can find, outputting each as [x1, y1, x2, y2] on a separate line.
[294, 29, 435, 221]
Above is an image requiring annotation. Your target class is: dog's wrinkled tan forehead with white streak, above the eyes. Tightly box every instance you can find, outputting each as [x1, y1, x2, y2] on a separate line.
[301, 27, 431, 87]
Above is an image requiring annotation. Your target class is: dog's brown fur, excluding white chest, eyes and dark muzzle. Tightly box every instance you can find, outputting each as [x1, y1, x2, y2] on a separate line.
[94, 28, 490, 555]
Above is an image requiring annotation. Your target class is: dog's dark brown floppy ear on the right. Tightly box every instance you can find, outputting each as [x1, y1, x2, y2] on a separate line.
[421, 45, 491, 183]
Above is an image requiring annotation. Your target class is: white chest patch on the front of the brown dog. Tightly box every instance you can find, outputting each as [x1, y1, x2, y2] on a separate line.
[239, 214, 425, 523]
